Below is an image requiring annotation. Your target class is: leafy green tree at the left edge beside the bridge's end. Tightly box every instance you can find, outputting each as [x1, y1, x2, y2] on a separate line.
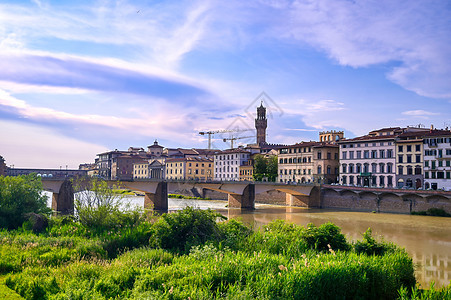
[0, 174, 51, 229]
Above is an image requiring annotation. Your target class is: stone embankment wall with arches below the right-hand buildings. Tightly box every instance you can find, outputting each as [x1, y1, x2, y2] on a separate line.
[321, 188, 451, 214]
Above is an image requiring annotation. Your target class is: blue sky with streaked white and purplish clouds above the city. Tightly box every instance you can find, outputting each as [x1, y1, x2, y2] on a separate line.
[0, 0, 451, 168]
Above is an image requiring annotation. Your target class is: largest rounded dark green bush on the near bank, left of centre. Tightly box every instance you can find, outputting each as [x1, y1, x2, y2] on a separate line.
[150, 207, 222, 253]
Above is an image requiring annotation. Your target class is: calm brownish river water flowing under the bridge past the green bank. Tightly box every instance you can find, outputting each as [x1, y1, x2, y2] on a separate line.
[47, 196, 451, 288]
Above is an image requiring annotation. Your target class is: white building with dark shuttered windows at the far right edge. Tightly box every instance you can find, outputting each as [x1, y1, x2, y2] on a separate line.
[423, 130, 451, 191]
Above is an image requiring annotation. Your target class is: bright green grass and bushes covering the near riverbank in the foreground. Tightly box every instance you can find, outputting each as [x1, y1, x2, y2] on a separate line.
[0, 208, 444, 299]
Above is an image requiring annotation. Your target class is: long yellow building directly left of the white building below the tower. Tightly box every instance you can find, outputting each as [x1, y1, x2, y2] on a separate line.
[166, 157, 214, 181]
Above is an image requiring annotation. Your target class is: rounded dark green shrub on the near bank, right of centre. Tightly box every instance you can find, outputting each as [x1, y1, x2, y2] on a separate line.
[301, 222, 350, 251]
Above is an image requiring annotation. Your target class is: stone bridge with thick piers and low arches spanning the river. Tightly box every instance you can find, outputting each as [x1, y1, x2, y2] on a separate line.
[42, 178, 321, 214]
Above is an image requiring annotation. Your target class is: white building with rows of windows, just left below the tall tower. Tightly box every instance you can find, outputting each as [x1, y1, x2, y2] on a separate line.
[214, 148, 251, 181]
